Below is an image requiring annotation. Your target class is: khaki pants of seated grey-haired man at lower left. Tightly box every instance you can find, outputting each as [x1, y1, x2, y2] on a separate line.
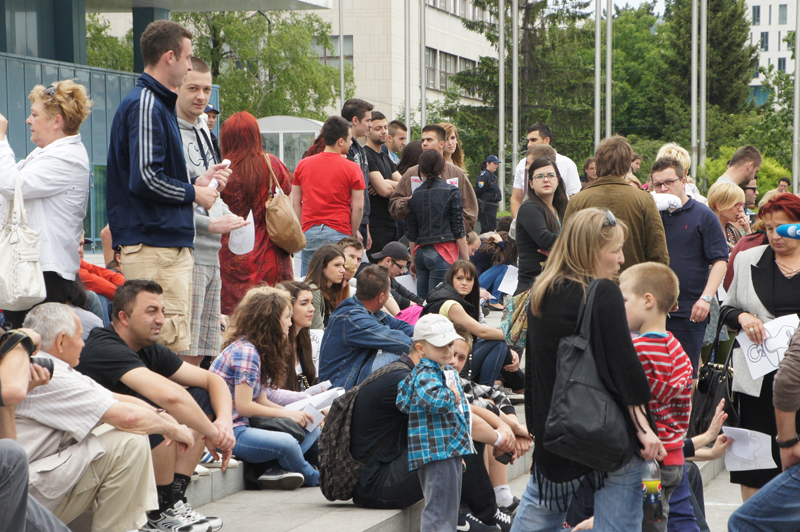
[53, 429, 158, 532]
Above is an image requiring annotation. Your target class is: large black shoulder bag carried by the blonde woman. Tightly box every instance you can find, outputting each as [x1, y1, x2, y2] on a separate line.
[543, 280, 631, 471]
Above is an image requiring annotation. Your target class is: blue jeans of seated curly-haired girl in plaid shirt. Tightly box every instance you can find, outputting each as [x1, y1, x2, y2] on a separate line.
[233, 425, 320, 486]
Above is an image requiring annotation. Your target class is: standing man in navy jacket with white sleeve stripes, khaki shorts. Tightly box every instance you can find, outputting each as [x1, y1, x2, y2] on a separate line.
[106, 20, 230, 352]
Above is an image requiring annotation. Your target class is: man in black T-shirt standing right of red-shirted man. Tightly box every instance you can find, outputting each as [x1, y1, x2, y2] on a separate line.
[364, 111, 402, 263]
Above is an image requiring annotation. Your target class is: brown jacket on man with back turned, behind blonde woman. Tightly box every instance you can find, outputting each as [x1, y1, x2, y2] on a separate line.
[564, 176, 669, 271]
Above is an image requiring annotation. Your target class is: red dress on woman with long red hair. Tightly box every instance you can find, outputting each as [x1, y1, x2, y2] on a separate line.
[219, 154, 294, 315]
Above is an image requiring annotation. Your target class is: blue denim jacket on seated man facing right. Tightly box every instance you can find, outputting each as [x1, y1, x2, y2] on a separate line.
[319, 296, 414, 390]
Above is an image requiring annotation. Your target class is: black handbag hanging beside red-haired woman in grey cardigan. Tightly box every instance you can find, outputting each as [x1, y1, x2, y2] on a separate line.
[687, 307, 739, 438]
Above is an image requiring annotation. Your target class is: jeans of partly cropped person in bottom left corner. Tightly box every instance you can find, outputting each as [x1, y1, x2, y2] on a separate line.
[0, 440, 69, 532]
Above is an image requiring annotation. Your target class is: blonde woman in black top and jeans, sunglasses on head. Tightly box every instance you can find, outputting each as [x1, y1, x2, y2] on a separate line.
[512, 208, 667, 532]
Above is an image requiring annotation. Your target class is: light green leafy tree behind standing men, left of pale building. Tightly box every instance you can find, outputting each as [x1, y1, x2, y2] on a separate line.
[172, 11, 355, 120]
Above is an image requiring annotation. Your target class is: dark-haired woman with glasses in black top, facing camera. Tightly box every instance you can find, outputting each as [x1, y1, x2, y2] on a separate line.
[514, 157, 567, 295]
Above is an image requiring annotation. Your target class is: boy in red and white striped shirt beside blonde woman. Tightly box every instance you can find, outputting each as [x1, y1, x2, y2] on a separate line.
[619, 262, 692, 532]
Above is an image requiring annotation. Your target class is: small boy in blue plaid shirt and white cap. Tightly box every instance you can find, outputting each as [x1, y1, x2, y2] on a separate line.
[397, 314, 474, 532]
